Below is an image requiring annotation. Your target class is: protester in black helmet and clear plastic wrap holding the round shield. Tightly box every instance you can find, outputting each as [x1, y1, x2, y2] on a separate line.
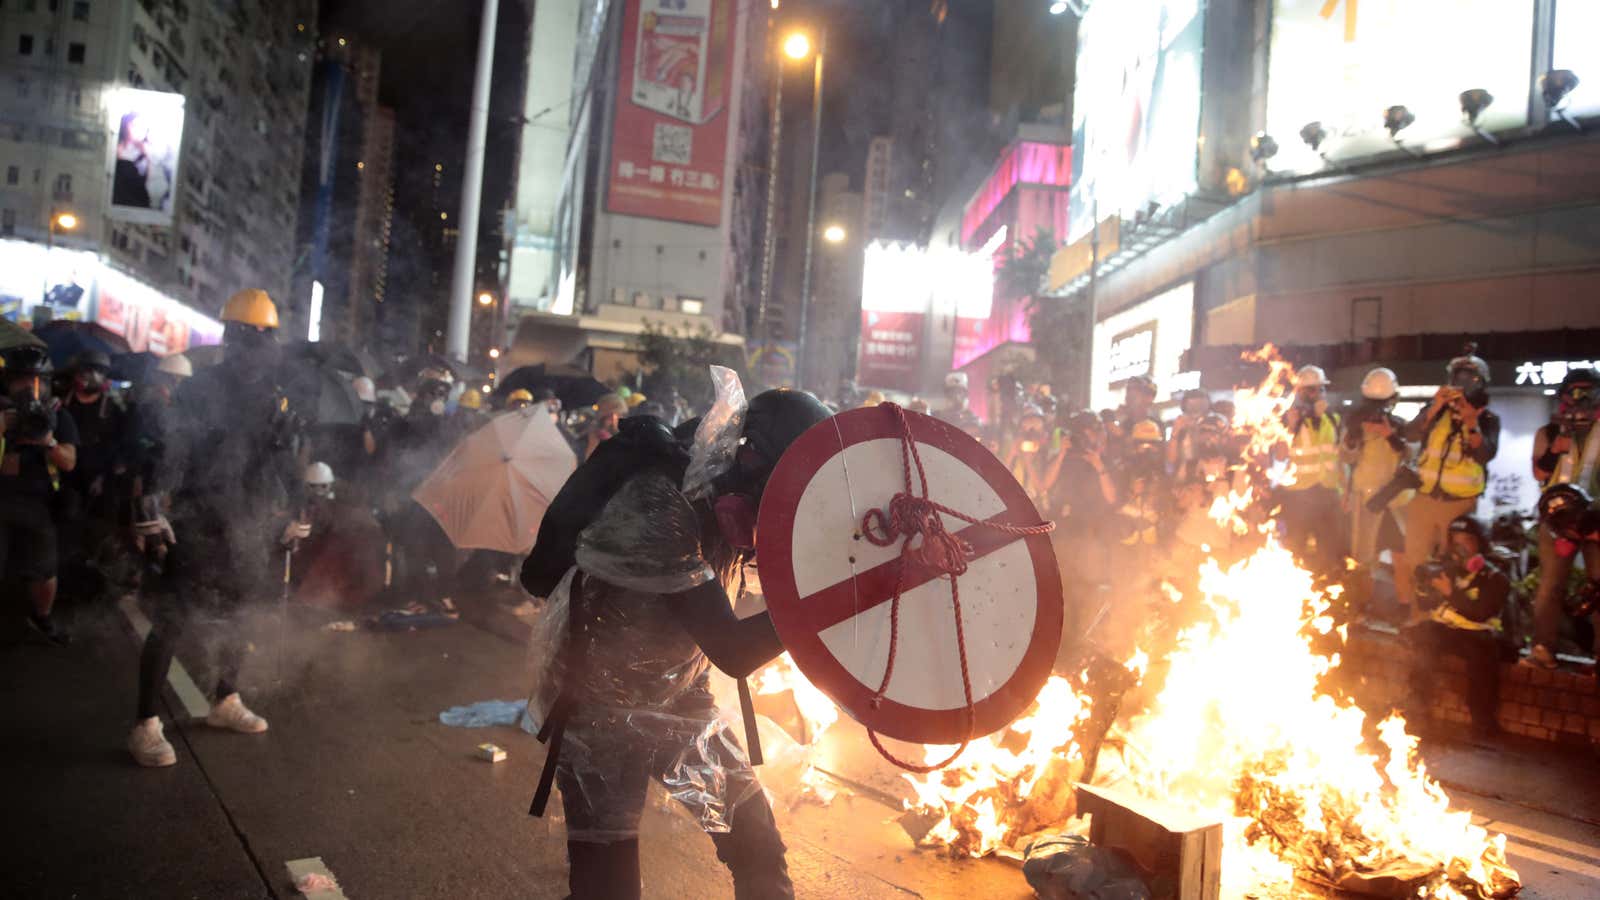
[523, 379, 827, 900]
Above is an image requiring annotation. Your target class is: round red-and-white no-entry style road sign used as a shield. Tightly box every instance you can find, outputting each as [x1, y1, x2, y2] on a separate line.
[755, 407, 1062, 745]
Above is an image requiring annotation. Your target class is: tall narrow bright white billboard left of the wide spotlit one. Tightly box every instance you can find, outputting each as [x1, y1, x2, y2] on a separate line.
[1067, 0, 1205, 242]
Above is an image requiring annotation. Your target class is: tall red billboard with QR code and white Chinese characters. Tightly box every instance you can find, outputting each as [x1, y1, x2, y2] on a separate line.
[606, 0, 736, 226]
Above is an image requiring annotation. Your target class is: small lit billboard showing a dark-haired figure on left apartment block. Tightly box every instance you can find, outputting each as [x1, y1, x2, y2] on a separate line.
[106, 88, 184, 224]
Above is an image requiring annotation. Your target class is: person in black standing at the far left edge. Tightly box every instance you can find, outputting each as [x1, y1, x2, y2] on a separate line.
[0, 346, 78, 645]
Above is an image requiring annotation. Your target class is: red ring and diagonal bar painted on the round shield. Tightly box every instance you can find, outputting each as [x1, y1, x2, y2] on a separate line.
[755, 407, 1064, 745]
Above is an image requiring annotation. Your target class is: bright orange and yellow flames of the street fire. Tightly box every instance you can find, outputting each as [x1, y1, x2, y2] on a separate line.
[757, 348, 1520, 898]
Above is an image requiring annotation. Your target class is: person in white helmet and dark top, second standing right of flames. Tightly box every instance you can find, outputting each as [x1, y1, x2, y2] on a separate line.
[1339, 368, 1411, 570]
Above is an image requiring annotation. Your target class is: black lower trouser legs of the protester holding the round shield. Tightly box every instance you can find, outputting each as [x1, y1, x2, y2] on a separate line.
[566, 793, 795, 900]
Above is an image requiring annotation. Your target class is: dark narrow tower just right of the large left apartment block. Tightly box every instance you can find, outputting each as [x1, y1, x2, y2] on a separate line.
[293, 35, 395, 342]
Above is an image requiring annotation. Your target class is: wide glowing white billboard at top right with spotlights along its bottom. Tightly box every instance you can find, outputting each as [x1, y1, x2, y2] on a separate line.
[1266, 0, 1529, 171]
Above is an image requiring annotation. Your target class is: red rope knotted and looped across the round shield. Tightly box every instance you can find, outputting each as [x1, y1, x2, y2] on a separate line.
[861, 404, 1056, 775]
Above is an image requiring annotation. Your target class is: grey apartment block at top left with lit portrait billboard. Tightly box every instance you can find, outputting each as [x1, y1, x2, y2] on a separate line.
[0, 0, 317, 329]
